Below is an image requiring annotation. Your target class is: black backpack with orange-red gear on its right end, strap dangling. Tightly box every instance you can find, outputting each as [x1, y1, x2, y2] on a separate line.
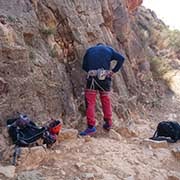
[6, 114, 61, 165]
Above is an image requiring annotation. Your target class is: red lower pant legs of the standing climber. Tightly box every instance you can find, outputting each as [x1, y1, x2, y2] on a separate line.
[85, 89, 112, 126]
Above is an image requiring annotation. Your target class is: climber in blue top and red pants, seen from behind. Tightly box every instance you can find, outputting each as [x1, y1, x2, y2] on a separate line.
[80, 43, 125, 136]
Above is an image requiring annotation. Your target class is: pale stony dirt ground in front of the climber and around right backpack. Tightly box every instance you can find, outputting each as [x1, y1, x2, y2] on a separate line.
[10, 95, 180, 180]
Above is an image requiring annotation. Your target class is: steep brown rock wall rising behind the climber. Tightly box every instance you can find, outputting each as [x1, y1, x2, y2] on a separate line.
[0, 0, 166, 126]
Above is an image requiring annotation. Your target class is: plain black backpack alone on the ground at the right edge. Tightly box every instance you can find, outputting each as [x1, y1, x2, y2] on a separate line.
[150, 121, 180, 143]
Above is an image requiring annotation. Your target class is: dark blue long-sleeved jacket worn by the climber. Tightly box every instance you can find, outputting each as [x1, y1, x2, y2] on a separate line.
[82, 44, 125, 73]
